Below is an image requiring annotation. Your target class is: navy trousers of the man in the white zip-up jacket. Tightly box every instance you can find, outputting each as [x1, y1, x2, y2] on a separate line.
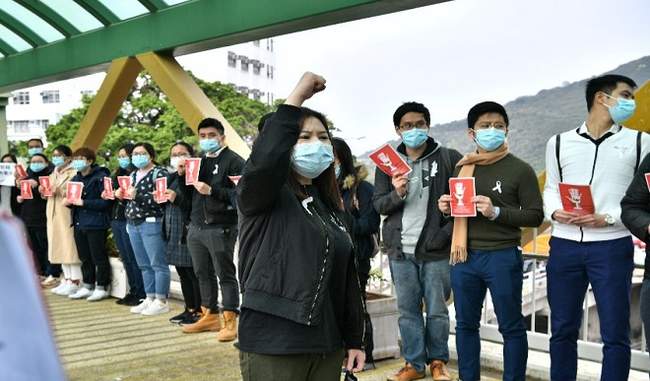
[546, 237, 634, 381]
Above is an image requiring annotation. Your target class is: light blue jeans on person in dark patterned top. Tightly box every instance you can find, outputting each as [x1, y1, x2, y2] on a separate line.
[126, 220, 171, 299]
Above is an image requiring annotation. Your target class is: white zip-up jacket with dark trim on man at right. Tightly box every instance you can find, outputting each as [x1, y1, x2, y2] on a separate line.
[544, 123, 650, 242]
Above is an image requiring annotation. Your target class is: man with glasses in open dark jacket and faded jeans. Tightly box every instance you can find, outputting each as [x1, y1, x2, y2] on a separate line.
[373, 102, 461, 381]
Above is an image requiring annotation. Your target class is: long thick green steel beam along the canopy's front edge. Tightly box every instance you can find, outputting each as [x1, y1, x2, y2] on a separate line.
[0, 0, 447, 92]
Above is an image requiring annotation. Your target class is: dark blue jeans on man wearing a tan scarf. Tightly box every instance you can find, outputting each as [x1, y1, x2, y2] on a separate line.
[451, 247, 528, 381]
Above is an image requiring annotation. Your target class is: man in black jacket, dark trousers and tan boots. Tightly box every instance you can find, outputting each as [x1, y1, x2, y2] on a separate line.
[172, 118, 244, 341]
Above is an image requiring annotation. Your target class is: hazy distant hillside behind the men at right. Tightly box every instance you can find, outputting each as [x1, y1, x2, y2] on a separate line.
[360, 56, 650, 172]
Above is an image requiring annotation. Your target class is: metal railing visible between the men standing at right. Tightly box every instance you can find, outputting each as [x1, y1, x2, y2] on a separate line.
[369, 231, 650, 372]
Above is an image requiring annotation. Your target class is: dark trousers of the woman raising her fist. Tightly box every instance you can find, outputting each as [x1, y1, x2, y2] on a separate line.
[239, 349, 345, 381]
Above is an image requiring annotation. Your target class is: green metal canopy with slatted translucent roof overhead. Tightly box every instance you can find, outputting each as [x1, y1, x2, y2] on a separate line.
[0, 0, 448, 93]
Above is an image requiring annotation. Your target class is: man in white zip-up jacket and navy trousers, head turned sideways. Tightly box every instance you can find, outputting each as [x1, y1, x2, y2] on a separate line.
[544, 75, 650, 381]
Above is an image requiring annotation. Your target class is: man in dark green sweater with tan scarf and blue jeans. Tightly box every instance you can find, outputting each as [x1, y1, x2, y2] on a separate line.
[438, 102, 544, 381]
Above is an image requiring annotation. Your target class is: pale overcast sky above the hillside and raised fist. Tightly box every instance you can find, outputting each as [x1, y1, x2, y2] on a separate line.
[181, 0, 650, 154]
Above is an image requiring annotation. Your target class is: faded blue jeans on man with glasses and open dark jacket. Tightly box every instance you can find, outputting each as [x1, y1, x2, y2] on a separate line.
[390, 254, 451, 372]
